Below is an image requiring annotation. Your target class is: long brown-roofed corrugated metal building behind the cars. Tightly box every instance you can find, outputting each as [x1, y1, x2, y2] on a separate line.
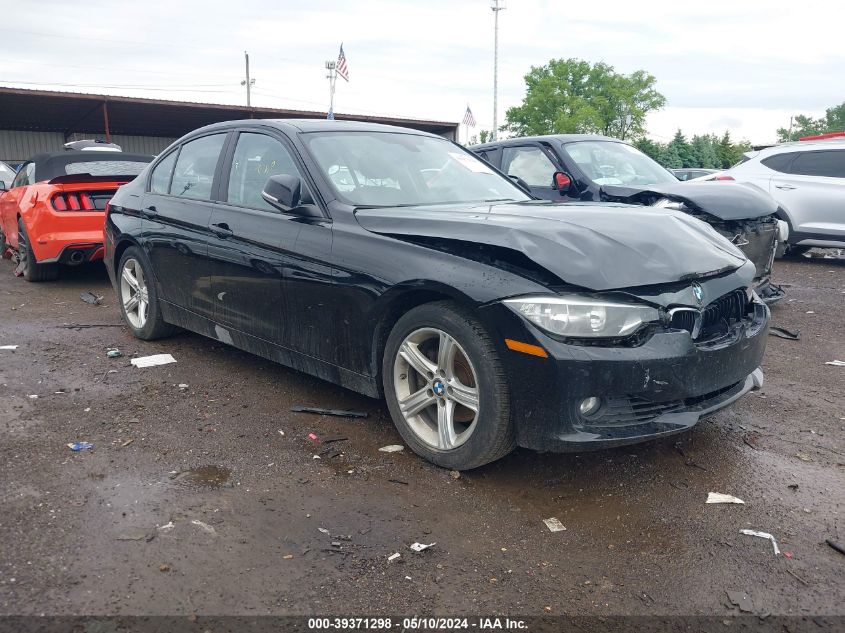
[0, 87, 458, 164]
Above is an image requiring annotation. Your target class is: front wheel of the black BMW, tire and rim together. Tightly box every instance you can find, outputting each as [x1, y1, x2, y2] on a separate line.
[382, 301, 516, 470]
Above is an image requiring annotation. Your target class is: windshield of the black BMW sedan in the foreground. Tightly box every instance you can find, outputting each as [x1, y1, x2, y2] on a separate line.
[302, 132, 531, 207]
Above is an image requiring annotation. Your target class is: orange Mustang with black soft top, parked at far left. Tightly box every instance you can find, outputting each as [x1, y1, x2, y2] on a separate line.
[0, 150, 153, 281]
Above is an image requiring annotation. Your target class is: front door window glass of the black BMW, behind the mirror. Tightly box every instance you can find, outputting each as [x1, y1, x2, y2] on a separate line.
[227, 132, 311, 212]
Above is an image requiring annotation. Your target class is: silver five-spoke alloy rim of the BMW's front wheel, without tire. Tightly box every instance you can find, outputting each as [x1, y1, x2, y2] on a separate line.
[393, 328, 480, 451]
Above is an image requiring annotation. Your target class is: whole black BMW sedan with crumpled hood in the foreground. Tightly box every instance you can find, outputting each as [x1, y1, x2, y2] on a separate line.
[105, 120, 769, 469]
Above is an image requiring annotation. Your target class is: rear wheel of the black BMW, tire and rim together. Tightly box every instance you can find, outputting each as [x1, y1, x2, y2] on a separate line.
[115, 246, 178, 341]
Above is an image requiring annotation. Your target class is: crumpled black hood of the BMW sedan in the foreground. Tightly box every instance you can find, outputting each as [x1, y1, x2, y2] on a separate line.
[355, 201, 746, 290]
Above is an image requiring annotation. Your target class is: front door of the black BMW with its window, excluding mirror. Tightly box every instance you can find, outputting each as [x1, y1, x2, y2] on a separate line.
[208, 130, 311, 346]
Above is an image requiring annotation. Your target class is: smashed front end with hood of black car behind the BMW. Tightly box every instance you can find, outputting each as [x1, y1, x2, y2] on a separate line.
[602, 182, 786, 305]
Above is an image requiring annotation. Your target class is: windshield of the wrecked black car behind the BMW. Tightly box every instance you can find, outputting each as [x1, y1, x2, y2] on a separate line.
[564, 141, 678, 185]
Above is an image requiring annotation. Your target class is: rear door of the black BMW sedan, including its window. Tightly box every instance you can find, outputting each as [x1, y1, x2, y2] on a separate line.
[141, 131, 229, 318]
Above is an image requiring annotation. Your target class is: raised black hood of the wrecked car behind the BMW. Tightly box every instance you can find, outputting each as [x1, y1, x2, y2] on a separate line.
[601, 181, 778, 220]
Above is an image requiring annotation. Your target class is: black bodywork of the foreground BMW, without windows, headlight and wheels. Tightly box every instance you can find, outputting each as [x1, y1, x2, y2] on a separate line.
[105, 121, 769, 450]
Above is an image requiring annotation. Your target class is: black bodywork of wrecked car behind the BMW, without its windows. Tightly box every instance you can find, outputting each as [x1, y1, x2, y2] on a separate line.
[470, 134, 785, 303]
